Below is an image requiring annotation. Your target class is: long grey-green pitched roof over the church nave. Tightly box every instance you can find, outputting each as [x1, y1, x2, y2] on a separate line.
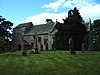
[25, 23, 55, 36]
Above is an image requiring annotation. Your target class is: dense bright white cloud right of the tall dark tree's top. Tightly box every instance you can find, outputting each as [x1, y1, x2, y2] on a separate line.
[80, 4, 100, 21]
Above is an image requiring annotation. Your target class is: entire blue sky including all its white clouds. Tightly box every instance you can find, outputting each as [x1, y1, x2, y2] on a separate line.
[0, 0, 100, 27]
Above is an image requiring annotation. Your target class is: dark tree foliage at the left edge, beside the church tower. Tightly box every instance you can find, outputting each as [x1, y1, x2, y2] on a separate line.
[0, 16, 13, 49]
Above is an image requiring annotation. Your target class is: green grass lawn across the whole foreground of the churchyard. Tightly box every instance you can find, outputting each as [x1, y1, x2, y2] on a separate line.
[0, 51, 100, 75]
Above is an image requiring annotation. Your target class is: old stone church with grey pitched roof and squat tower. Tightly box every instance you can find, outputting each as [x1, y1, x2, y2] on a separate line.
[13, 20, 57, 50]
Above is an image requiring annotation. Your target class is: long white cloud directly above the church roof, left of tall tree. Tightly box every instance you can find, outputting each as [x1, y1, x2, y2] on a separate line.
[21, 12, 67, 25]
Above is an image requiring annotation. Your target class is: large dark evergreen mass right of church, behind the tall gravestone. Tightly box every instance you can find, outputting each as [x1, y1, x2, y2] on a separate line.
[55, 7, 87, 53]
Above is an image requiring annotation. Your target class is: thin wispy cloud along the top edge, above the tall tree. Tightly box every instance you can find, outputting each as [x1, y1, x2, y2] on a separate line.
[42, 0, 96, 12]
